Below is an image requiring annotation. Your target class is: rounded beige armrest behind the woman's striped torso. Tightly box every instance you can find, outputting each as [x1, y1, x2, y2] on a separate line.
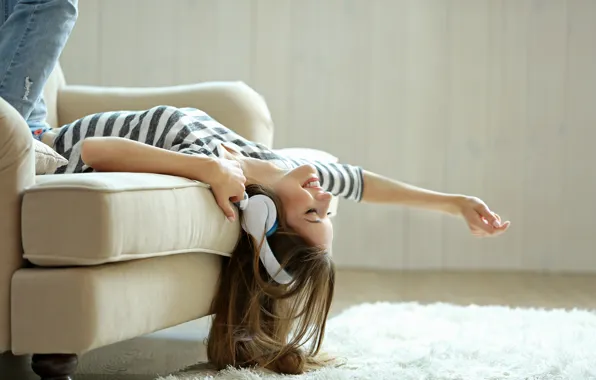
[58, 82, 273, 147]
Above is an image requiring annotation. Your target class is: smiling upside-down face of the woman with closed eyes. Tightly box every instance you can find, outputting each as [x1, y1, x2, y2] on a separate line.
[273, 165, 333, 250]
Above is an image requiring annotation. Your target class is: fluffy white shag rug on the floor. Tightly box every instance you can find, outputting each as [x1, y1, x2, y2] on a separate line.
[161, 303, 596, 380]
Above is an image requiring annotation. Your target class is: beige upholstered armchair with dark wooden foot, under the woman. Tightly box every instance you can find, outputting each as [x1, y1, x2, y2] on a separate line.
[0, 63, 337, 379]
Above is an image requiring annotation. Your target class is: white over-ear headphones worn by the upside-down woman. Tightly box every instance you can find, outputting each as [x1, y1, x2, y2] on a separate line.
[237, 193, 292, 284]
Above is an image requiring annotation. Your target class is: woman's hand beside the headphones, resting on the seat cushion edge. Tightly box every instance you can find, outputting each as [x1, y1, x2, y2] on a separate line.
[205, 158, 246, 222]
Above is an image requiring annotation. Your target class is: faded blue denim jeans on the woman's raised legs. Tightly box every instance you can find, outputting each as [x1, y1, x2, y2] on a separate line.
[0, 0, 78, 129]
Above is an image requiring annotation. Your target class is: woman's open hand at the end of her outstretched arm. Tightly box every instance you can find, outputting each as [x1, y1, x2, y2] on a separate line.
[455, 197, 511, 237]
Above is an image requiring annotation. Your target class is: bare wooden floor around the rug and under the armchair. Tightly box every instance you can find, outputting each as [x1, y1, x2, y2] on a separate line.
[0, 270, 596, 380]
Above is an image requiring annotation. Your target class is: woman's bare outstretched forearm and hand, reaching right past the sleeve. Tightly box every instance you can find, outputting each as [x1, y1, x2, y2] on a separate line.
[362, 170, 510, 236]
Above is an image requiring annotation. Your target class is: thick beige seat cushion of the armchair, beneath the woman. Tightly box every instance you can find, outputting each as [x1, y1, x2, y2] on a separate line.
[22, 173, 240, 266]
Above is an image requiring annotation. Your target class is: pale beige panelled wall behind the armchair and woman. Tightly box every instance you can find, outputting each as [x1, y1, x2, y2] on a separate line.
[62, 0, 596, 271]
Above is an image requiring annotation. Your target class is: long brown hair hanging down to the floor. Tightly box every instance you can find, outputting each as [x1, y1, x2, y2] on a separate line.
[207, 185, 335, 374]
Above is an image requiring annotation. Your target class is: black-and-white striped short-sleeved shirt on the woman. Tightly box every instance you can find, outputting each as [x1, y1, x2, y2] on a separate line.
[53, 106, 363, 201]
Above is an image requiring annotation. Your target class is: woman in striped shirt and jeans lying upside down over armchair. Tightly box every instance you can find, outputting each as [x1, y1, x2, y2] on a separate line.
[0, 0, 509, 374]
